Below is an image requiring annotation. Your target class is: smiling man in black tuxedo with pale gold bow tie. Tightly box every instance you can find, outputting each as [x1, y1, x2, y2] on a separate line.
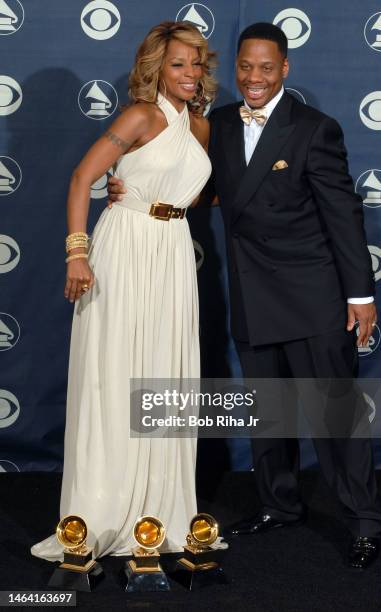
[109, 23, 381, 568]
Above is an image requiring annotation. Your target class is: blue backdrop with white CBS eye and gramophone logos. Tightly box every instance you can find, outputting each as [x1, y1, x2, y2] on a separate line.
[0, 0, 381, 471]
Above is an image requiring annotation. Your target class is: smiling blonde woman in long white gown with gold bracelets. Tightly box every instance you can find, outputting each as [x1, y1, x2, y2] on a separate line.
[32, 22, 215, 561]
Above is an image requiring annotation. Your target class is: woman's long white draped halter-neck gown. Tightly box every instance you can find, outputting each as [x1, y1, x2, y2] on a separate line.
[32, 94, 211, 561]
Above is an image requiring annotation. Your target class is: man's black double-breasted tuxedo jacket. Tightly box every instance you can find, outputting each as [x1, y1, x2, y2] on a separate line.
[209, 93, 374, 345]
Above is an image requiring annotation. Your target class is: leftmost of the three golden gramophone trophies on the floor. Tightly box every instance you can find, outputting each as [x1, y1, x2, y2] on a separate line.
[48, 515, 104, 591]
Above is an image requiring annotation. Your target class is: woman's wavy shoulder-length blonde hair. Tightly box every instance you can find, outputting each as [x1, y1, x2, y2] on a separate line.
[128, 21, 217, 115]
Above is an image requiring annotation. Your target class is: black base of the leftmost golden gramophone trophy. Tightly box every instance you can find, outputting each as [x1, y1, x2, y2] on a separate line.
[48, 561, 104, 592]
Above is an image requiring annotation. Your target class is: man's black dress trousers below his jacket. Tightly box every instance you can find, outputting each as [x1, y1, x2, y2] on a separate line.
[236, 330, 381, 537]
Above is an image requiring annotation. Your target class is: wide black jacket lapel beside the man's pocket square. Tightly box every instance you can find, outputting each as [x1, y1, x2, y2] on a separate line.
[231, 93, 295, 228]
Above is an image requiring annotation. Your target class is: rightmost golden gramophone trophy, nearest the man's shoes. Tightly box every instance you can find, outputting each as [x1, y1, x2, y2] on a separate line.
[173, 512, 228, 590]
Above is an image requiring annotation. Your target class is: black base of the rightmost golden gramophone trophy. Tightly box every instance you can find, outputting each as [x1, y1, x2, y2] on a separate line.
[171, 559, 229, 591]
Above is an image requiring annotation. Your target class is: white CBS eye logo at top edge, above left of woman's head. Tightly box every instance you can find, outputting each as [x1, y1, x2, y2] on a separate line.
[81, 0, 120, 40]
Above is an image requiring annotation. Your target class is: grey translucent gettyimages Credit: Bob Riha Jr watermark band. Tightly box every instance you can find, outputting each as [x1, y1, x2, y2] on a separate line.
[130, 378, 381, 438]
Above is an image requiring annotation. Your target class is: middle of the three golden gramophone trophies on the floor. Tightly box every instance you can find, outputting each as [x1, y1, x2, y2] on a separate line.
[125, 516, 170, 592]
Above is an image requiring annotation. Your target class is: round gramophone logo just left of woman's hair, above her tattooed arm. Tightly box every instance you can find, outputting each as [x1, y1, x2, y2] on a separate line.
[78, 79, 118, 121]
